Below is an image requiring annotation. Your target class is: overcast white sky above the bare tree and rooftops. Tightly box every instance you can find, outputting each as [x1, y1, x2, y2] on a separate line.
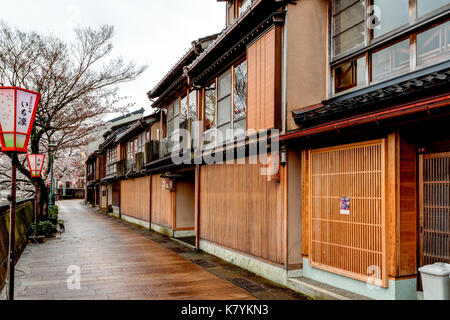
[0, 0, 225, 119]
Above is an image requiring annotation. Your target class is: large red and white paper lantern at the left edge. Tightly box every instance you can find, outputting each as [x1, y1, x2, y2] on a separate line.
[0, 87, 40, 152]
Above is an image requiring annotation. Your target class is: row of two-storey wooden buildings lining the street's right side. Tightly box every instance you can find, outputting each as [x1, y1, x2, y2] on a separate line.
[87, 0, 450, 299]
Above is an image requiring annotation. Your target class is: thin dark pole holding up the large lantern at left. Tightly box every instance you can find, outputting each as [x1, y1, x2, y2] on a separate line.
[8, 153, 16, 300]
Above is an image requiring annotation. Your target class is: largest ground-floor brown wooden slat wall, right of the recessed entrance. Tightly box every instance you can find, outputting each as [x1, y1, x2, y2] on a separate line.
[200, 159, 285, 264]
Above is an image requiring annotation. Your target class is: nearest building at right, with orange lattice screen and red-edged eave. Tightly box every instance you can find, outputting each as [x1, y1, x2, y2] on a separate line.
[280, 0, 450, 299]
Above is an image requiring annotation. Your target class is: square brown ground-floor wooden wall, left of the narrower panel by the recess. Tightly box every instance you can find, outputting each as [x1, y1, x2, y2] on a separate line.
[120, 177, 150, 222]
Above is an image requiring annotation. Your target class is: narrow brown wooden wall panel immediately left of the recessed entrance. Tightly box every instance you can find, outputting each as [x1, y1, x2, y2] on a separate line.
[151, 175, 173, 228]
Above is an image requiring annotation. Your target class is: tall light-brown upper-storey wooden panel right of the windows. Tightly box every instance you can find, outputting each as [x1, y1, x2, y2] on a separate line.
[247, 27, 281, 130]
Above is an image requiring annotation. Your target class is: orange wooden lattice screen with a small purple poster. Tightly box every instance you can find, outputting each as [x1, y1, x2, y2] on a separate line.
[310, 140, 387, 286]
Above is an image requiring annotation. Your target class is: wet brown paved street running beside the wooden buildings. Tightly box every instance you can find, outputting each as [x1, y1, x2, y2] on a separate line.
[8, 200, 305, 300]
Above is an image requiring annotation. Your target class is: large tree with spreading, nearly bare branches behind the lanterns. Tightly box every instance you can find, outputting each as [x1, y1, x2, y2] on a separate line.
[0, 22, 146, 218]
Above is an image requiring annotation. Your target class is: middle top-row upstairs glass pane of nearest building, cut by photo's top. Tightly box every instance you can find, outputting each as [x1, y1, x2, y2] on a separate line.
[373, 0, 409, 38]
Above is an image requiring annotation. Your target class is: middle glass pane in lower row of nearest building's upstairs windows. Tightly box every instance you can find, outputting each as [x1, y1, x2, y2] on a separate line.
[372, 39, 410, 82]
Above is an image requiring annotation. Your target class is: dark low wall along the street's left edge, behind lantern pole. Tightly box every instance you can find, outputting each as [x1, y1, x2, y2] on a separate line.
[0, 198, 34, 290]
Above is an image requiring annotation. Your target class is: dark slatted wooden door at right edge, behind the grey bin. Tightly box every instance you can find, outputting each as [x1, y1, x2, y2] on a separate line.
[419, 152, 450, 266]
